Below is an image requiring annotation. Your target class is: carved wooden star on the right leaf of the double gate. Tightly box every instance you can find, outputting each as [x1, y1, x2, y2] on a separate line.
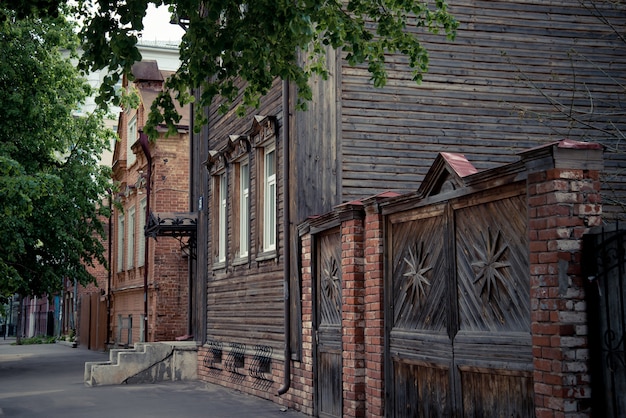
[472, 229, 511, 301]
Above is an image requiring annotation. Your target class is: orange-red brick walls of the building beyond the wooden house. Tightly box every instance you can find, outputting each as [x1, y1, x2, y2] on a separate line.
[111, 129, 189, 342]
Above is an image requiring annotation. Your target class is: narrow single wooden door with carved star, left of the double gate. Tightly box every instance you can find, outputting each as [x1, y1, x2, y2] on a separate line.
[315, 229, 342, 417]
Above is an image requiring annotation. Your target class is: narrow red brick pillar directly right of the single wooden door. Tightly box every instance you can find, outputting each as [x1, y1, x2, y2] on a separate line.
[341, 212, 365, 417]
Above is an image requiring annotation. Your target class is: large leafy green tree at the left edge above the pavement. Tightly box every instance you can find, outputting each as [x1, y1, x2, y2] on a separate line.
[0, 10, 113, 295]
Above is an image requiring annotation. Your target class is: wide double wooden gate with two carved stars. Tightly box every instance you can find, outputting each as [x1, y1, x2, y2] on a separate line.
[385, 184, 534, 417]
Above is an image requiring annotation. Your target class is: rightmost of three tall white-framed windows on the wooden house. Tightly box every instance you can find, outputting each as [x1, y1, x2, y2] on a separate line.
[262, 145, 276, 252]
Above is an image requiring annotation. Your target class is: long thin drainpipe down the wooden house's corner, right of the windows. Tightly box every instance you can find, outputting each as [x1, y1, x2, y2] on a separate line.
[278, 80, 291, 396]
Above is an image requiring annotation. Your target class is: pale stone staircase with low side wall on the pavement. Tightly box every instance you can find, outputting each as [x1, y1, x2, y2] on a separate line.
[85, 341, 198, 386]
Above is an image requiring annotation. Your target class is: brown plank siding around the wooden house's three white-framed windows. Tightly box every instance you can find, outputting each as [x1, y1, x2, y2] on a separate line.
[206, 81, 284, 353]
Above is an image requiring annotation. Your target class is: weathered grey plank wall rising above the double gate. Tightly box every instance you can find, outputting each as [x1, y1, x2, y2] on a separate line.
[341, 0, 626, 219]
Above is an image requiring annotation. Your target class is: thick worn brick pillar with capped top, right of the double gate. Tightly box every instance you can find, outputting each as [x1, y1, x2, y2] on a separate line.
[522, 141, 602, 418]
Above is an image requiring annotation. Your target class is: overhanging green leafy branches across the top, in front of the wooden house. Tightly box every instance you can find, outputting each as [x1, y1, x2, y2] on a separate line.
[76, 0, 457, 137]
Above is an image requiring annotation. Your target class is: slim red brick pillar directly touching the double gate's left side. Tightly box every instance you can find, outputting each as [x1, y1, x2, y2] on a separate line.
[365, 200, 385, 417]
